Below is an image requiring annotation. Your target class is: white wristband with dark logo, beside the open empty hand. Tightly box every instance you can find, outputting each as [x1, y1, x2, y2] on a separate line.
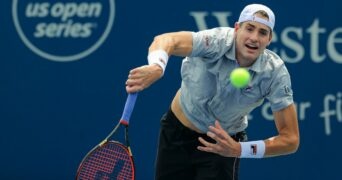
[240, 140, 266, 158]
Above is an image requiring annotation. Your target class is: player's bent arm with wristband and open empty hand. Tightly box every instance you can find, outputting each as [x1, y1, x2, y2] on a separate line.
[197, 104, 299, 158]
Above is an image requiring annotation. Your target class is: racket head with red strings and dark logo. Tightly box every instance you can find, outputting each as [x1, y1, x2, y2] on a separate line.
[76, 141, 135, 180]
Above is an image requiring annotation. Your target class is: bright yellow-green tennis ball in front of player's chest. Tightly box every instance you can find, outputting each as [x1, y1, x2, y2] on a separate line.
[230, 68, 251, 88]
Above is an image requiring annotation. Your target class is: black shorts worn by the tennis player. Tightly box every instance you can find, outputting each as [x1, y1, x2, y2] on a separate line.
[155, 110, 247, 180]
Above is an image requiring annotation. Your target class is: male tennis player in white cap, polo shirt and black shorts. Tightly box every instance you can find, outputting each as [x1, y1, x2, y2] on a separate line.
[126, 4, 299, 180]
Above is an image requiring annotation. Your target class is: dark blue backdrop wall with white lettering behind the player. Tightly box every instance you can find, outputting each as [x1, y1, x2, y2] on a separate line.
[0, 0, 342, 180]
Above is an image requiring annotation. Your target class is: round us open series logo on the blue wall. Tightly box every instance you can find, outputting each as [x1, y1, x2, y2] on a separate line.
[12, 0, 115, 62]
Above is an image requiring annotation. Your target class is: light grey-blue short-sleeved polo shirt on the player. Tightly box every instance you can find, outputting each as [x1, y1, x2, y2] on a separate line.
[180, 27, 293, 134]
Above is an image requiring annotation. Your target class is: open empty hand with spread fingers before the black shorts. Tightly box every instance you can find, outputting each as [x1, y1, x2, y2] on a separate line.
[197, 121, 241, 157]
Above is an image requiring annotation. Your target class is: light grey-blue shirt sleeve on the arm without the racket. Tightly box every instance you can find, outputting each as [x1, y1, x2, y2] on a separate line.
[266, 65, 293, 112]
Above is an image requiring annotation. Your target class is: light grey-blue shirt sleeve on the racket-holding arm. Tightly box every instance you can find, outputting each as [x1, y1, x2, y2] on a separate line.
[189, 27, 234, 61]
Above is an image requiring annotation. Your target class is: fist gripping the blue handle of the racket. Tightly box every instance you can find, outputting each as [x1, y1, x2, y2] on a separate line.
[126, 64, 163, 93]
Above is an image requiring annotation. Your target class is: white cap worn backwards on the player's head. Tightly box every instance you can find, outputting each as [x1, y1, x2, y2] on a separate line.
[238, 4, 275, 30]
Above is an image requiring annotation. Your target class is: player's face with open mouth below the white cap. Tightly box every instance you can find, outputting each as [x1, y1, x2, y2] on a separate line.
[235, 16, 272, 67]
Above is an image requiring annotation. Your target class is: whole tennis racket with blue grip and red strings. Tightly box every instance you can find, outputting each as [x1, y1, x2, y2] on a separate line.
[76, 93, 138, 180]
